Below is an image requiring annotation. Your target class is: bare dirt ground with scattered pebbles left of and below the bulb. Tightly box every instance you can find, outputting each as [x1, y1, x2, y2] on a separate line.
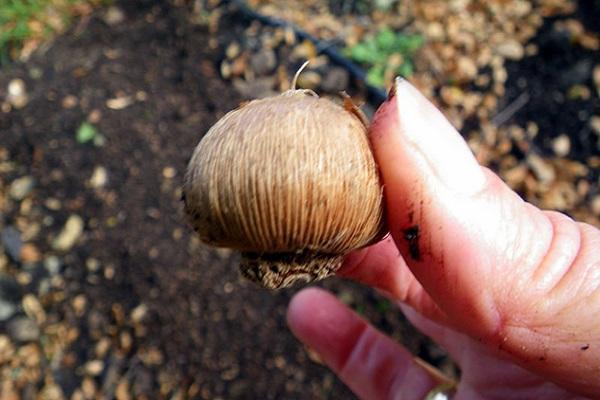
[0, 1, 432, 399]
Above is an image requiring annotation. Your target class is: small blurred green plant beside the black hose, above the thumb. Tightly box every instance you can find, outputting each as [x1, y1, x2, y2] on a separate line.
[345, 28, 424, 86]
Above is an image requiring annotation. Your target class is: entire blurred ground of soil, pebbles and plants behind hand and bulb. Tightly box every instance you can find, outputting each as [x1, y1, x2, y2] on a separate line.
[0, 0, 600, 400]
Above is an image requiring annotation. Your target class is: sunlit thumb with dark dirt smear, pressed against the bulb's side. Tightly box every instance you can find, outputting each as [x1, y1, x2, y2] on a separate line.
[371, 79, 600, 394]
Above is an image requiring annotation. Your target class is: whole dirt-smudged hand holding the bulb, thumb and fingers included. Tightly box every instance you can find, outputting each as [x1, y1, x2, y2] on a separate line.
[288, 79, 600, 400]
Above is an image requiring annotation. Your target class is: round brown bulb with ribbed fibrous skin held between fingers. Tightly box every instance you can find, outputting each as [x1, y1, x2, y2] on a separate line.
[184, 90, 384, 289]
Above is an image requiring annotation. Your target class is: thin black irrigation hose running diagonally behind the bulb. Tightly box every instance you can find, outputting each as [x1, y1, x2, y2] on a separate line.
[226, 0, 387, 106]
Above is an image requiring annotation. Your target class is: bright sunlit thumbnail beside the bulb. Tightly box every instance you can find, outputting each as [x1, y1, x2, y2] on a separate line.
[394, 78, 486, 194]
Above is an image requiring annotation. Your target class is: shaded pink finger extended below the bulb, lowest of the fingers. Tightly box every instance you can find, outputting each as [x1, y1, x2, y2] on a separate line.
[288, 288, 436, 399]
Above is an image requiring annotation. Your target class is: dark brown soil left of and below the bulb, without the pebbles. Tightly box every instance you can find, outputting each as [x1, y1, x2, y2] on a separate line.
[0, 0, 432, 399]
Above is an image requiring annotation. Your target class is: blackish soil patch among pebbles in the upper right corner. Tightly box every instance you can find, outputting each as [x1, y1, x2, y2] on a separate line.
[500, 0, 600, 162]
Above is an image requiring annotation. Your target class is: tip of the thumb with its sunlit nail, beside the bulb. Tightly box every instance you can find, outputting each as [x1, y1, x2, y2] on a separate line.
[370, 79, 486, 200]
